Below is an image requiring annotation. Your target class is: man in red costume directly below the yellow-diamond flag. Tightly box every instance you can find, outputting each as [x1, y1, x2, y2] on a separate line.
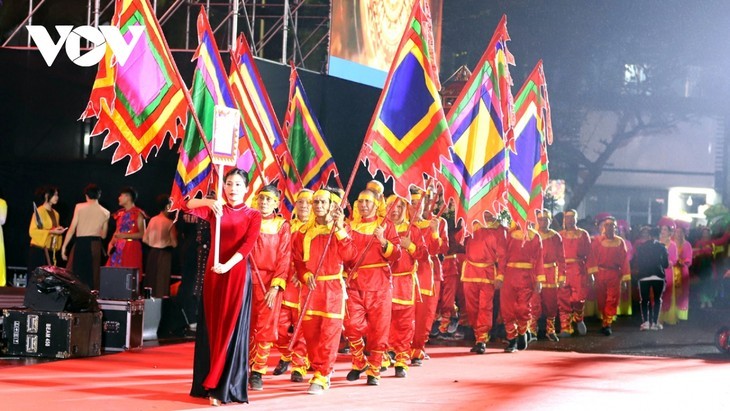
[461, 211, 506, 354]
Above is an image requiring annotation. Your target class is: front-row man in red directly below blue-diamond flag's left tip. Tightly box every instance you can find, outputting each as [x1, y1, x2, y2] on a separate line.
[345, 190, 401, 385]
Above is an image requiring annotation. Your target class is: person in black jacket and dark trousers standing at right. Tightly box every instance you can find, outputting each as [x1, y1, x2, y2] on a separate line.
[634, 227, 669, 331]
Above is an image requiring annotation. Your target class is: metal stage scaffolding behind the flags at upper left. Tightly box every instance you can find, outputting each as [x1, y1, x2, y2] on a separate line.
[2, 0, 330, 72]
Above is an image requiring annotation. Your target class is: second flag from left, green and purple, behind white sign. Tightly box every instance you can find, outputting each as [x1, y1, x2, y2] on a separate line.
[171, 7, 236, 208]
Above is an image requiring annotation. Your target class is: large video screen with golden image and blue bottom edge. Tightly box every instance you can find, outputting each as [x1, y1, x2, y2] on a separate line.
[329, 0, 443, 87]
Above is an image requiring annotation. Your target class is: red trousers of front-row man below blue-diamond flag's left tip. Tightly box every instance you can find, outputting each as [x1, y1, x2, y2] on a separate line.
[345, 288, 392, 378]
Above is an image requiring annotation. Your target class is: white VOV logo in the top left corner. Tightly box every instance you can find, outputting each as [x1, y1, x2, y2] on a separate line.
[26, 25, 145, 67]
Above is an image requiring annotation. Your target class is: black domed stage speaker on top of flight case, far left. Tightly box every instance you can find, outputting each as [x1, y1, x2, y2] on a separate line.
[23, 265, 99, 312]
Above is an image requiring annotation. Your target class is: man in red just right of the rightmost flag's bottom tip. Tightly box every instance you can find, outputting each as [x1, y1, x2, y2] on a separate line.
[530, 209, 565, 342]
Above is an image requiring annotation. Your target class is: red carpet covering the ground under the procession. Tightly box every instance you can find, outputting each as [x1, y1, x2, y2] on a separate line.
[0, 343, 730, 411]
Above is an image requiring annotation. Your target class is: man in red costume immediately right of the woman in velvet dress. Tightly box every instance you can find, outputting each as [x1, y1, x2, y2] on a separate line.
[249, 185, 291, 391]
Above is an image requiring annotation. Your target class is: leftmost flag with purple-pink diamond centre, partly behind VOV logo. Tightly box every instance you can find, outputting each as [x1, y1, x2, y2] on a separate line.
[81, 0, 187, 175]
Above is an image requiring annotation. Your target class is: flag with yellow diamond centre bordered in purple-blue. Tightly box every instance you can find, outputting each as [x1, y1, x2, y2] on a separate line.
[439, 16, 511, 231]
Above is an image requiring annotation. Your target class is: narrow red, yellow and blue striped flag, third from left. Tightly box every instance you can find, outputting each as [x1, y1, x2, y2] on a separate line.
[229, 35, 301, 216]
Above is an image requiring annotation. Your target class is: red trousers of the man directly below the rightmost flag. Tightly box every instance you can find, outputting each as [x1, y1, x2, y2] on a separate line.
[498, 267, 534, 340]
